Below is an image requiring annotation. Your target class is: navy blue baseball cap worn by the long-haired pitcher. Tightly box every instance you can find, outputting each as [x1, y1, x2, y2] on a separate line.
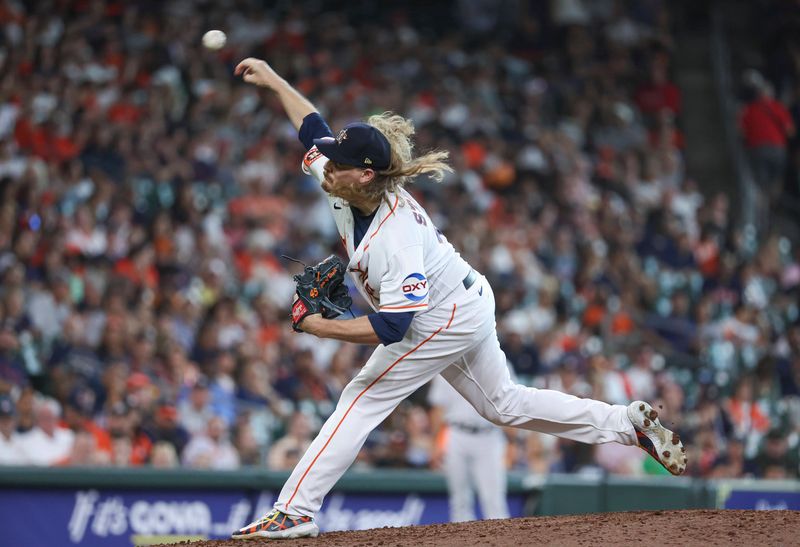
[314, 122, 392, 171]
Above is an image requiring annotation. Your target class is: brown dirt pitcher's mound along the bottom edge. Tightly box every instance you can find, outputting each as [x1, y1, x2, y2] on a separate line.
[161, 510, 800, 547]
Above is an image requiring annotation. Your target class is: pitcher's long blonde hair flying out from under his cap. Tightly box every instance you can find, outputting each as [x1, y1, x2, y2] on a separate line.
[363, 112, 453, 198]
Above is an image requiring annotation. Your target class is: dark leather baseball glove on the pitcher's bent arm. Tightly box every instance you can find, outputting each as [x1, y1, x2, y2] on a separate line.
[292, 255, 353, 332]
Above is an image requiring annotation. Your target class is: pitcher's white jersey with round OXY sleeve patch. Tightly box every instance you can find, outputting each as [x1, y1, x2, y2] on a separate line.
[303, 146, 470, 313]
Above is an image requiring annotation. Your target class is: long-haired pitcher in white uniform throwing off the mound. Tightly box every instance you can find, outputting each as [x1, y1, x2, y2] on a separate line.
[232, 58, 686, 539]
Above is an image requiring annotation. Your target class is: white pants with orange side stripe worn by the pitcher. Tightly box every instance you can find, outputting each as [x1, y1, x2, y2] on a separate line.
[275, 276, 636, 516]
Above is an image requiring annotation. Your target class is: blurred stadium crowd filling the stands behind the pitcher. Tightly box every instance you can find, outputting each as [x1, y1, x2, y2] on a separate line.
[0, 0, 800, 478]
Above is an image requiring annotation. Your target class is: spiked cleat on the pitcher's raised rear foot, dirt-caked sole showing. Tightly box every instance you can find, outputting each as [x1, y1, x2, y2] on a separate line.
[628, 401, 689, 475]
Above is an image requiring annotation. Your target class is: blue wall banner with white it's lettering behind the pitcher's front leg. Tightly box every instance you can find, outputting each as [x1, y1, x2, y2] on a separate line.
[0, 489, 524, 547]
